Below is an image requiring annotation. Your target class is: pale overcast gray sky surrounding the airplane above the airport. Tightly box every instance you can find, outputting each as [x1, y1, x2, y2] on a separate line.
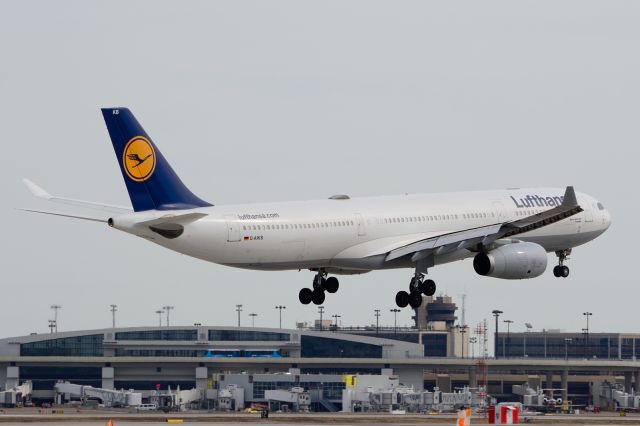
[0, 0, 640, 337]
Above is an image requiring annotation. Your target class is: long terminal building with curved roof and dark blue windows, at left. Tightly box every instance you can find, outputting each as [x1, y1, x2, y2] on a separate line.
[0, 326, 425, 398]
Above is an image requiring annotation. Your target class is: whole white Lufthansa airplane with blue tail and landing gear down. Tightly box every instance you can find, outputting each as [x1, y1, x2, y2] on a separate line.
[22, 108, 611, 308]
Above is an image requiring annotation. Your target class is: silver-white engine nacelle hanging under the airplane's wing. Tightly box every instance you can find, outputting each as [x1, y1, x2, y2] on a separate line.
[473, 243, 547, 280]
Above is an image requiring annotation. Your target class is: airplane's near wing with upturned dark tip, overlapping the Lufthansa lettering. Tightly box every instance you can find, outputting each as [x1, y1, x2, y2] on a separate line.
[385, 186, 583, 262]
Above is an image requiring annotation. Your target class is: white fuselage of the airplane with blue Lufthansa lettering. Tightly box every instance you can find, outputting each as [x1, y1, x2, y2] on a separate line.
[113, 188, 611, 273]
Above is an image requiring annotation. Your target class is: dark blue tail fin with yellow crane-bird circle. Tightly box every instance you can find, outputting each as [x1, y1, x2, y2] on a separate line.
[102, 108, 211, 212]
